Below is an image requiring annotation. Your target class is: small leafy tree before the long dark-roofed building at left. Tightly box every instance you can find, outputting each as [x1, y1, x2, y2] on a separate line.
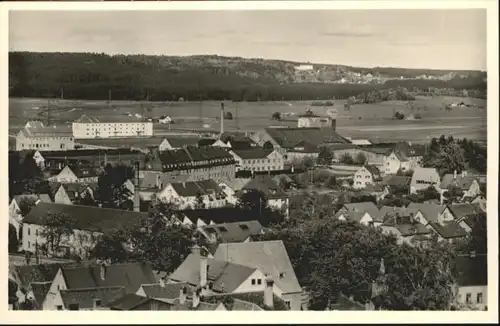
[40, 211, 75, 255]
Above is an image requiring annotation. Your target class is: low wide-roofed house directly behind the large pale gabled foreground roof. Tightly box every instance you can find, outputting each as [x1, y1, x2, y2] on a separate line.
[199, 221, 264, 243]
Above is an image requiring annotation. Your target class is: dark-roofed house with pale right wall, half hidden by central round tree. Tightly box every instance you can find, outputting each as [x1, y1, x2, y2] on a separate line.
[240, 175, 290, 217]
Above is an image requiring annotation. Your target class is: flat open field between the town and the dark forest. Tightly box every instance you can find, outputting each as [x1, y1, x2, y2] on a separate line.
[9, 97, 487, 141]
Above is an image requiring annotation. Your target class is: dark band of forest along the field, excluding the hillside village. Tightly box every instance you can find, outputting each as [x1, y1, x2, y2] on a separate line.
[9, 52, 486, 101]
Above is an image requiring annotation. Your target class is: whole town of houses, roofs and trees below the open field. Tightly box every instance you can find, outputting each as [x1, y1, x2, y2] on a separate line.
[9, 103, 488, 311]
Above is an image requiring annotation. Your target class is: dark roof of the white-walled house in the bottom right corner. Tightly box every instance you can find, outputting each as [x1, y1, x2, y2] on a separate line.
[455, 256, 488, 286]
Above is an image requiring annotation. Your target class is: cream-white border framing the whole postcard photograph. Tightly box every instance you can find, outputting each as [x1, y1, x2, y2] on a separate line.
[0, 0, 499, 324]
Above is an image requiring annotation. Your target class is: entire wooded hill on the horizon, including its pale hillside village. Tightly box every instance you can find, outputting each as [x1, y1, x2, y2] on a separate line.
[9, 52, 486, 101]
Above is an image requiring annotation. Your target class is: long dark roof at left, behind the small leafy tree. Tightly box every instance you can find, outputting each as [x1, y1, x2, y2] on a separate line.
[24, 202, 148, 233]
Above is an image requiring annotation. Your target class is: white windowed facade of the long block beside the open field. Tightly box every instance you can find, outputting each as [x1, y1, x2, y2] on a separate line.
[72, 122, 153, 139]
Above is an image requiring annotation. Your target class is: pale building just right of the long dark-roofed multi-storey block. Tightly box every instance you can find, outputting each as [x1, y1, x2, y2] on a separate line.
[229, 148, 284, 172]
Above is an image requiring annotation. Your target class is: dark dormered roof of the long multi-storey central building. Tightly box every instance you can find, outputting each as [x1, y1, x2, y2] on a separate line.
[159, 146, 235, 172]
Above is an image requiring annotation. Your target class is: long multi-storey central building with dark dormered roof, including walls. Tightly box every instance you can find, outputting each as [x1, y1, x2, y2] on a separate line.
[145, 146, 236, 180]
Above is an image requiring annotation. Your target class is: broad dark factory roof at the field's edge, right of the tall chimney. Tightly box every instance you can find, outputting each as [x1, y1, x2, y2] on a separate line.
[265, 128, 349, 148]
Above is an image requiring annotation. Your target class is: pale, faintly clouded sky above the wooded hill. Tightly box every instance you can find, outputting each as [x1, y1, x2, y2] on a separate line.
[9, 9, 487, 70]
